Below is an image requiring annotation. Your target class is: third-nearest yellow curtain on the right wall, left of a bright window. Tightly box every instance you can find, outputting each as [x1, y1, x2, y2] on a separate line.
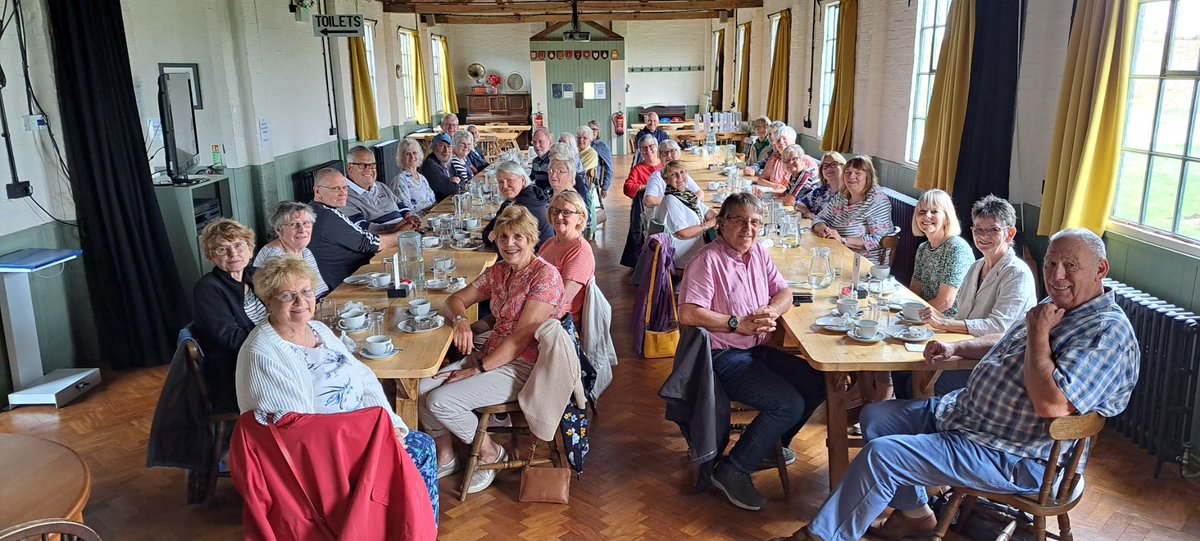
[821, 0, 858, 152]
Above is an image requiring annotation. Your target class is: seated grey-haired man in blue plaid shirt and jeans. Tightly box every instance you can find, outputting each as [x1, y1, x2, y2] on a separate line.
[772, 229, 1140, 541]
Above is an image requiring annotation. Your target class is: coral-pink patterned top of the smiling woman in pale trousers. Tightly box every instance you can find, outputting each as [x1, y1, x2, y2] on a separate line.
[474, 257, 565, 365]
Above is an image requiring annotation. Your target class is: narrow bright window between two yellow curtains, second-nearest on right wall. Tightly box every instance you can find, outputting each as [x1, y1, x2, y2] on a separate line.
[908, 0, 950, 163]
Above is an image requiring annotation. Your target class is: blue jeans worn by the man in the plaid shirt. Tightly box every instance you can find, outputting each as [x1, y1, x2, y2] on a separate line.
[809, 398, 1045, 541]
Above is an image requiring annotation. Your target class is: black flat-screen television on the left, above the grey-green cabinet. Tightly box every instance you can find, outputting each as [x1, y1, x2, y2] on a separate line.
[158, 73, 200, 182]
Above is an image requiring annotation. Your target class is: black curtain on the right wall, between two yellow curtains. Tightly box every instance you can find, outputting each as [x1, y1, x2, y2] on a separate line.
[954, 0, 1025, 248]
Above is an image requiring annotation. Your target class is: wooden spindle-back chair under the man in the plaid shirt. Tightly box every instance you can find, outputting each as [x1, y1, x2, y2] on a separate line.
[936, 411, 1104, 541]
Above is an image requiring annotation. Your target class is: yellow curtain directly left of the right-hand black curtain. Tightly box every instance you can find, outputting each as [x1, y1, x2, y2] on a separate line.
[916, 0, 974, 194]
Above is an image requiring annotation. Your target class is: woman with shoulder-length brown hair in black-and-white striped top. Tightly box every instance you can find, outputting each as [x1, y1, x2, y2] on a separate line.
[812, 156, 892, 264]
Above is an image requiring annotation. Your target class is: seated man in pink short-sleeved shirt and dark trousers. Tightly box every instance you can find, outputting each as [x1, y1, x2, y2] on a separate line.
[679, 193, 826, 511]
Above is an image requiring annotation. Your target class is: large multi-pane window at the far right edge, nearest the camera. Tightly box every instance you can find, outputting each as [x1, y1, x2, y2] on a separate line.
[1112, 0, 1200, 241]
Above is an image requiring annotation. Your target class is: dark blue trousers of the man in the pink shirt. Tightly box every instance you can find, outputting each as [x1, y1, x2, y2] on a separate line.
[713, 345, 826, 473]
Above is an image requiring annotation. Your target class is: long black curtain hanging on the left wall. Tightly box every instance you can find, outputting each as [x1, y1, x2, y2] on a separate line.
[47, 0, 188, 368]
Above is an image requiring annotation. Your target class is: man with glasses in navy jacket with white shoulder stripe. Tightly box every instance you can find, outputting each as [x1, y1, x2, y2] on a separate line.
[308, 168, 396, 287]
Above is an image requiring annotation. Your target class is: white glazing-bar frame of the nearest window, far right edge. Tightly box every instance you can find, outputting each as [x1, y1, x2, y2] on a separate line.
[1108, 0, 1200, 248]
